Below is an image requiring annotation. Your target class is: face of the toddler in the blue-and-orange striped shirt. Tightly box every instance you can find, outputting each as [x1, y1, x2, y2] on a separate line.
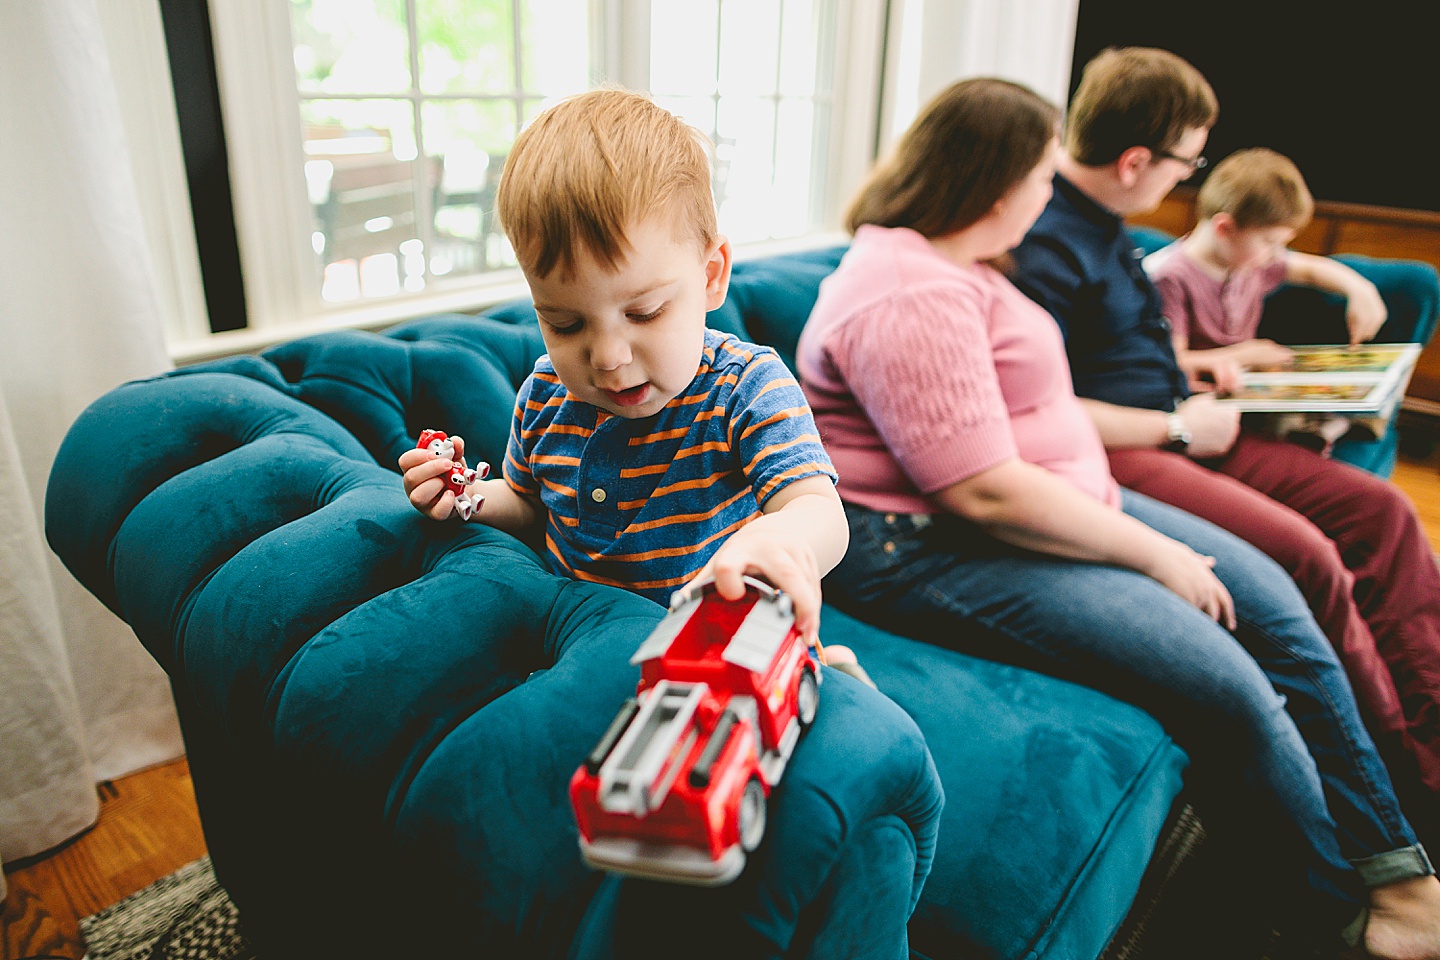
[526, 216, 730, 420]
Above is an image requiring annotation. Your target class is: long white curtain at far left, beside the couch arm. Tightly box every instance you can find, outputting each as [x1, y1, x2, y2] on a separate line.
[0, 0, 183, 894]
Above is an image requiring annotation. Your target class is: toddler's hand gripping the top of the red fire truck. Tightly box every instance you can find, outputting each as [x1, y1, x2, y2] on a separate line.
[696, 517, 821, 646]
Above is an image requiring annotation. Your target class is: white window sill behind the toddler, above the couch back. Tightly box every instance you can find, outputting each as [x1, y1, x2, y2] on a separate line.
[170, 232, 850, 367]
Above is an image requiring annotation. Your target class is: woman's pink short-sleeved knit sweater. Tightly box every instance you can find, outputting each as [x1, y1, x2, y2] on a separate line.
[798, 226, 1120, 514]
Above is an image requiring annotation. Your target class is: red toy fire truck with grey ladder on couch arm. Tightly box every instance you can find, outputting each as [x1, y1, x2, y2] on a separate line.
[570, 577, 821, 887]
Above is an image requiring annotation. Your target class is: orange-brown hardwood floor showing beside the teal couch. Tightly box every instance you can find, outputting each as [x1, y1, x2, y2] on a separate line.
[8, 440, 1440, 960]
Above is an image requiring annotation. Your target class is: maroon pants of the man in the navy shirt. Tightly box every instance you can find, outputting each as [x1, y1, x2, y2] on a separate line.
[1110, 433, 1440, 793]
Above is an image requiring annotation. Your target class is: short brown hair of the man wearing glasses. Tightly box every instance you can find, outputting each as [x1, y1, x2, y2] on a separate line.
[1066, 46, 1220, 167]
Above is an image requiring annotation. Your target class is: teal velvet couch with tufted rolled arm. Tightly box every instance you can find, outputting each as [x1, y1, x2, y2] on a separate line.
[46, 249, 1194, 960]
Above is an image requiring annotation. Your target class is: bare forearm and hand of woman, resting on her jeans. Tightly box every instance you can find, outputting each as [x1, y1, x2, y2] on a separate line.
[933, 458, 1236, 629]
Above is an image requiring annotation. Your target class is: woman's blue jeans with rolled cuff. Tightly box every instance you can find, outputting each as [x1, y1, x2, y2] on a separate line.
[825, 491, 1434, 923]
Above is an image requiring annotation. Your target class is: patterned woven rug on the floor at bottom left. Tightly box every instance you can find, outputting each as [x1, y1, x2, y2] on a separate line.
[81, 856, 255, 960]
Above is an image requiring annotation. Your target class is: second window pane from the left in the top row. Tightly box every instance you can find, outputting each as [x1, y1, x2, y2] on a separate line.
[415, 0, 516, 94]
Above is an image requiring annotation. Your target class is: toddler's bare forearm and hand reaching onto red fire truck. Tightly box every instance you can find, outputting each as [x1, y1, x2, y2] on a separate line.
[696, 476, 850, 642]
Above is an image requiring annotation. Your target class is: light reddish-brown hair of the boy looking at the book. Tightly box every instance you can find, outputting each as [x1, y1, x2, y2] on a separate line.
[1195, 147, 1315, 230]
